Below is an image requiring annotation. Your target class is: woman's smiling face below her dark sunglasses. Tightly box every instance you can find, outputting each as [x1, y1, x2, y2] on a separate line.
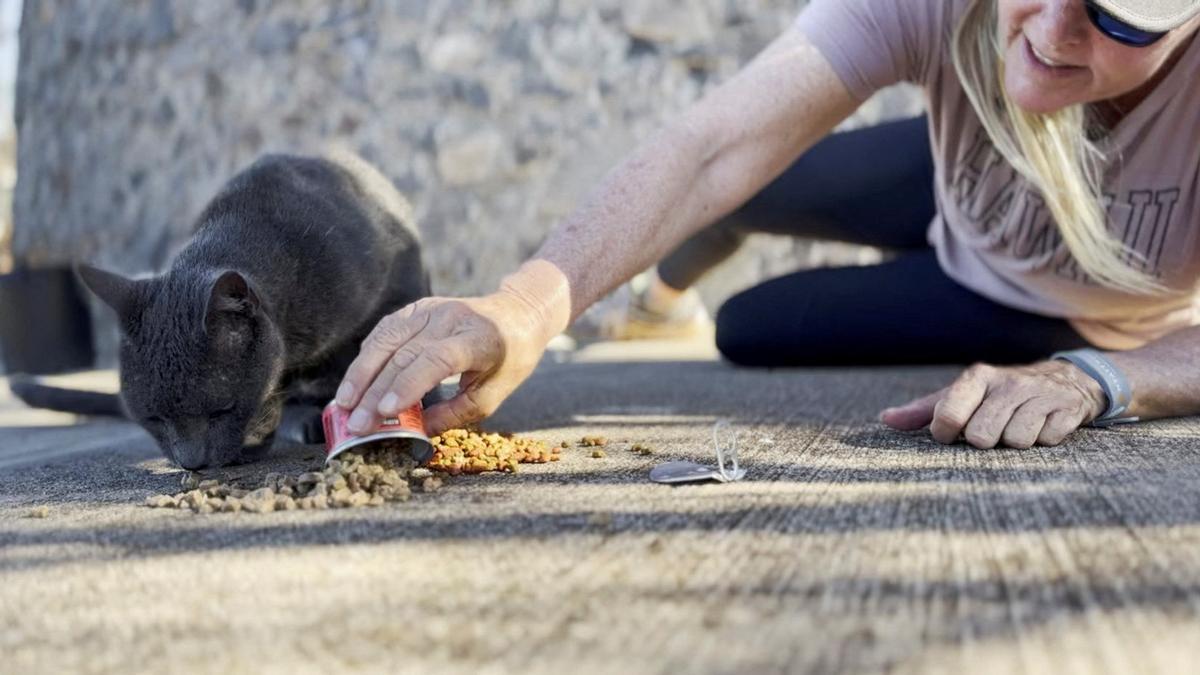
[997, 0, 1200, 113]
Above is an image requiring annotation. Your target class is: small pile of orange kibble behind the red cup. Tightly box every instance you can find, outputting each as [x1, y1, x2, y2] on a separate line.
[428, 429, 562, 476]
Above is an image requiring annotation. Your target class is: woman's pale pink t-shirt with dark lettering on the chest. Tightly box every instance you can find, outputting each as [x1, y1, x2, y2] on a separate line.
[797, 0, 1200, 350]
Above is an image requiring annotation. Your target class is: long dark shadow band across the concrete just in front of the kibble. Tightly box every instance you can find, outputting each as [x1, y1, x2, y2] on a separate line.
[7, 473, 1200, 571]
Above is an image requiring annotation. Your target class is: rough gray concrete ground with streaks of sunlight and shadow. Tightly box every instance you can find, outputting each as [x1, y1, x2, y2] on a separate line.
[0, 345, 1200, 674]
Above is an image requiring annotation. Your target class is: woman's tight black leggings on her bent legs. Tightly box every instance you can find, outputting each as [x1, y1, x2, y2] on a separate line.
[658, 118, 1090, 366]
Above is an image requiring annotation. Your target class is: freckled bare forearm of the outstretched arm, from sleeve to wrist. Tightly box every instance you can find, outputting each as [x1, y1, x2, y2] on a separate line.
[505, 30, 857, 327]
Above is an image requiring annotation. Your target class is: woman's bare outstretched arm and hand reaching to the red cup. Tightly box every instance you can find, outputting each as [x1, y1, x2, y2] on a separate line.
[337, 28, 858, 434]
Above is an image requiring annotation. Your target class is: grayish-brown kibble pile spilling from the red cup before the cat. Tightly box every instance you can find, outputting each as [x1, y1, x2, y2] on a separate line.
[145, 444, 420, 513]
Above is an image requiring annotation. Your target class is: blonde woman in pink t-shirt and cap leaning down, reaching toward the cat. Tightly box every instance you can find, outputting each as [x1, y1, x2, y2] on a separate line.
[338, 0, 1200, 448]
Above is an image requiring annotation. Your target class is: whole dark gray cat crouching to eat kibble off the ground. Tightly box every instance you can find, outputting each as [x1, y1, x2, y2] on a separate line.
[14, 154, 430, 470]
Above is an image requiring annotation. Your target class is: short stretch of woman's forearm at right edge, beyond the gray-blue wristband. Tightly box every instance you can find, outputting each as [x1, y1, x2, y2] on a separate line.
[1105, 327, 1200, 419]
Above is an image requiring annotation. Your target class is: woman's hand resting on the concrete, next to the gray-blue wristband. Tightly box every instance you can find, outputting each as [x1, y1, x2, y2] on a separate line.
[880, 360, 1106, 448]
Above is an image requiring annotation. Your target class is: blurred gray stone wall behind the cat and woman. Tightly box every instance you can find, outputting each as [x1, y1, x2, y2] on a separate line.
[13, 0, 917, 365]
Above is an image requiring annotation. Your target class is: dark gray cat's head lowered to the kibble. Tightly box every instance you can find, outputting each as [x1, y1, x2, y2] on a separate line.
[79, 267, 283, 468]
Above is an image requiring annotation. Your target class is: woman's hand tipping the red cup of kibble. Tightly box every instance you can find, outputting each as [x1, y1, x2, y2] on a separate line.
[337, 260, 569, 435]
